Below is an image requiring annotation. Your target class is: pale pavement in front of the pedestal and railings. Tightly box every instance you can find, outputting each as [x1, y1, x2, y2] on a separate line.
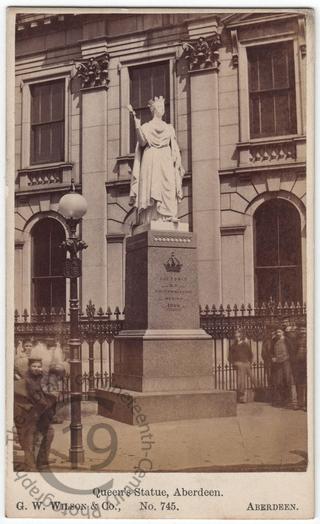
[16, 402, 307, 472]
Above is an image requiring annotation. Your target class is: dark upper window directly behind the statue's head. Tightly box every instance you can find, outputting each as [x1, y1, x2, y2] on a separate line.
[129, 62, 170, 153]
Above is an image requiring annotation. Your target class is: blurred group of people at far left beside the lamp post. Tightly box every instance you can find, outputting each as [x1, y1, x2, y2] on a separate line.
[14, 340, 66, 471]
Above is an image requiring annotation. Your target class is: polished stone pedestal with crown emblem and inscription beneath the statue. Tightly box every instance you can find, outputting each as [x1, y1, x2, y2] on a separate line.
[97, 225, 236, 424]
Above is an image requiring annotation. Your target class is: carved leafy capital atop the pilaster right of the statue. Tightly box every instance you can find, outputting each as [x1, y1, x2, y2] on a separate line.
[182, 32, 222, 72]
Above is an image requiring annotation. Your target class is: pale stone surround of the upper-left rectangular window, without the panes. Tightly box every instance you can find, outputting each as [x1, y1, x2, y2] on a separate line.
[21, 68, 71, 170]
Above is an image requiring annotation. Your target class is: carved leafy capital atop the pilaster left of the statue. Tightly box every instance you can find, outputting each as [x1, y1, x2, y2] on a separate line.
[76, 53, 110, 89]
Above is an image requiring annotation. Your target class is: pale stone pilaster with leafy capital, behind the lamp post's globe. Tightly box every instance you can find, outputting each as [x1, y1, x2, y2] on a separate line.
[77, 49, 109, 306]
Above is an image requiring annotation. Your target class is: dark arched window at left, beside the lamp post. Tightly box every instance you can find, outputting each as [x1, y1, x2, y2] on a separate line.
[31, 218, 66, 312]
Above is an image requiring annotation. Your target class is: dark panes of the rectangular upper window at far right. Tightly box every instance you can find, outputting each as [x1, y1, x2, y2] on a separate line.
[247, 42, 297, 138]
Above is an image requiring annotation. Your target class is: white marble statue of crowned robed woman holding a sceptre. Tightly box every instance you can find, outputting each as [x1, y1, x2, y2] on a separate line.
[128, 96, 184, 225]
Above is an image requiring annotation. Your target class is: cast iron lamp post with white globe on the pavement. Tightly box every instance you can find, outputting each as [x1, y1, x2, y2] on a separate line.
[59, 179, 87, 469]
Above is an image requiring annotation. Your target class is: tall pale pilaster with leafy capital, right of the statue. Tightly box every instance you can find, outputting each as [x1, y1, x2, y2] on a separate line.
[183, 18, 221, 304]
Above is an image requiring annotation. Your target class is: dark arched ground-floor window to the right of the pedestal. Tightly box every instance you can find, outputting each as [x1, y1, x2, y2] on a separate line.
[254, 198, 302, 303]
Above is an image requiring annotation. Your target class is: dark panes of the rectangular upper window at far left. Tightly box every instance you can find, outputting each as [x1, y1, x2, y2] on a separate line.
[30, 80, 65, 164]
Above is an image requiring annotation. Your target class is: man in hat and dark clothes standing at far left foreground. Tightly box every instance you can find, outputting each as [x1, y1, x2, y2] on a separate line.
[14, 357, 54, 471]
